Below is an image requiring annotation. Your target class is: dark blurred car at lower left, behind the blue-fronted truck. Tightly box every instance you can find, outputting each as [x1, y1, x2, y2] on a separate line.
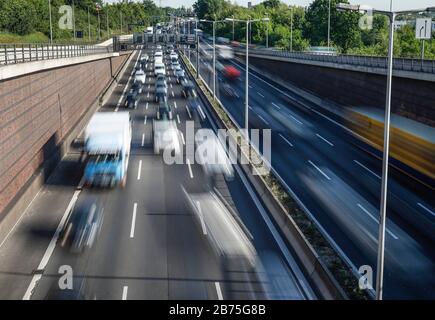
[61, 197, 104, 253]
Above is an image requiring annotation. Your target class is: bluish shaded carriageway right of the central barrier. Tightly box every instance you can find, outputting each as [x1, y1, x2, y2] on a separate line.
[191, 43, 435, 298]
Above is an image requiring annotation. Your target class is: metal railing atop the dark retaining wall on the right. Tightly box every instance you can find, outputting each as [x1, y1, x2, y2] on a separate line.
[235, 48, 435, 74]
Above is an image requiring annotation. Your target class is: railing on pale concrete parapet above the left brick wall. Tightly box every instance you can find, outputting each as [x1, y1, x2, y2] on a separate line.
[0, 44, 113, 66]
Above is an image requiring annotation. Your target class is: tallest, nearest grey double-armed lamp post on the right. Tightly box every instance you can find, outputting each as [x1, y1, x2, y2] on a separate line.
[337, 3, 435, 300]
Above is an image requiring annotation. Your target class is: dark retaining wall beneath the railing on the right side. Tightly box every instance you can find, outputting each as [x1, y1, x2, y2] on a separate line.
[245, 57, 435, 126]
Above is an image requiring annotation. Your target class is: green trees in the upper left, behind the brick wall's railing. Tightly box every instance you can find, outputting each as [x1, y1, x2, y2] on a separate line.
[0, 0, 169, 42]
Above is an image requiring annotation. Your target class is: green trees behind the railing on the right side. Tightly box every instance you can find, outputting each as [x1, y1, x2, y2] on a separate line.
[193, 0, 435, 59]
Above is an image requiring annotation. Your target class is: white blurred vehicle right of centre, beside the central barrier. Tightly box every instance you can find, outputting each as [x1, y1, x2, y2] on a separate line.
[195, 131, 234, 180]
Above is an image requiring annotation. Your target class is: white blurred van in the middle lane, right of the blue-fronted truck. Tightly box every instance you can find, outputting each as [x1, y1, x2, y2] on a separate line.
[153, 119, 181, 155]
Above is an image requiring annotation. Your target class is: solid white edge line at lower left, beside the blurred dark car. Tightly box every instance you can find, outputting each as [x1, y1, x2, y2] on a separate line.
[23, 190, 81, 300]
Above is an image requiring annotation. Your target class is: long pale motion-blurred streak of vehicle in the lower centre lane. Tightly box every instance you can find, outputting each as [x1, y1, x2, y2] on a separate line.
[182, 187, 266, 299]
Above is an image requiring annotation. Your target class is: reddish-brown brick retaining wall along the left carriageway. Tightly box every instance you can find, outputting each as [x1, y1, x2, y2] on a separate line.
[0, 55, 127, 216]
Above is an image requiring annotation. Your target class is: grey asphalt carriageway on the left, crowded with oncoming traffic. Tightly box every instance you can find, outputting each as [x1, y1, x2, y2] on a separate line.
[0, 45, 315, 299]
